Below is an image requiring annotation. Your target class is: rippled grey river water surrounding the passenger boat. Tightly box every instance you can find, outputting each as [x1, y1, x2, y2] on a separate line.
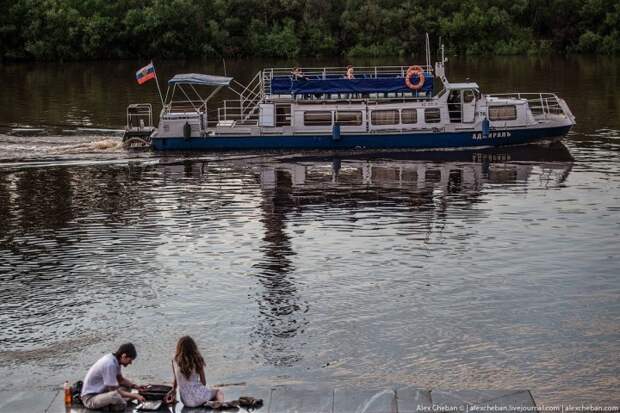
[0, 58, 620, 405]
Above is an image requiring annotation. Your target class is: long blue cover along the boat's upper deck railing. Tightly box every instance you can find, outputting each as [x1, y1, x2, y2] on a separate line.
[271, 72, 433, 95]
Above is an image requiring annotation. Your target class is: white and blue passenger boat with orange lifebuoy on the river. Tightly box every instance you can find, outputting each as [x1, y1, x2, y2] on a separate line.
[125, 57, 575, 151]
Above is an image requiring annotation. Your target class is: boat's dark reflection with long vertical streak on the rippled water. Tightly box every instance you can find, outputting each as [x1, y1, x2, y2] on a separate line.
[159, 143, 573, 367]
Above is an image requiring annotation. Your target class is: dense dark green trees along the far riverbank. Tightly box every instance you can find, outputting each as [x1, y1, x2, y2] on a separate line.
[0, 0, 620, 60]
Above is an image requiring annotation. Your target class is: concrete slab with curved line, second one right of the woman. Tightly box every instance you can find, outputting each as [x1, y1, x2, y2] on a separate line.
[334, 388, 397, 413]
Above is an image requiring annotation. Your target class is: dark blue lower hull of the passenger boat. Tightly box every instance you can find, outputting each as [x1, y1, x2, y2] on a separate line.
[151, 126, 570, 151]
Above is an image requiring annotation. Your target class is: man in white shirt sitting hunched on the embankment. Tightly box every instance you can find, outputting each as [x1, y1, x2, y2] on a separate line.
[80, 343, 144, 411]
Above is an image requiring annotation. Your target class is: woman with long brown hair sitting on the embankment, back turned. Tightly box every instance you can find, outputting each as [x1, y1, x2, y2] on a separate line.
[165, 336, 224, 407]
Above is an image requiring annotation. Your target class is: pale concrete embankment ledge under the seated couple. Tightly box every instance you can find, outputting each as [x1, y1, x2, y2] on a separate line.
[0, 386, 536, 413]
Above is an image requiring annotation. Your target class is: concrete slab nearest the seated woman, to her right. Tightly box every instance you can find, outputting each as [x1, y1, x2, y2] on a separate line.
[269, 387, 334, 413]
